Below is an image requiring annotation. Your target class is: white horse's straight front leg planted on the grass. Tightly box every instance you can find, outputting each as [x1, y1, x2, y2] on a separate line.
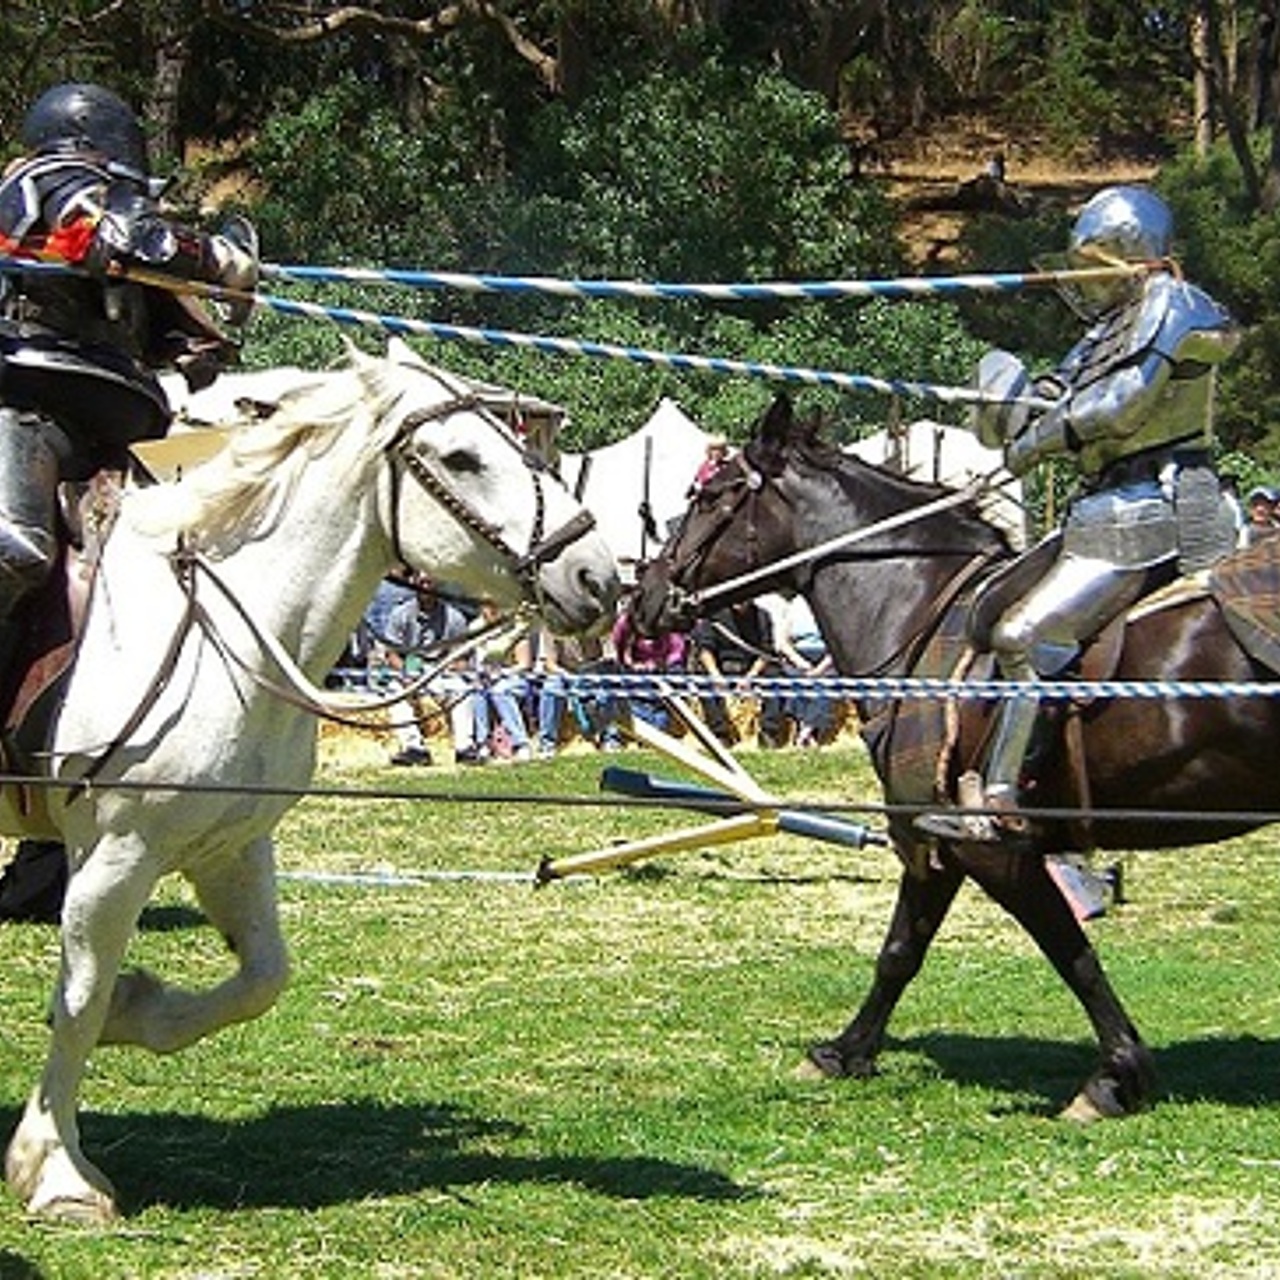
[5, 836, 156, 1224]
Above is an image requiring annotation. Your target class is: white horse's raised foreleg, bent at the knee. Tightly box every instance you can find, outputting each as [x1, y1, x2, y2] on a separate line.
[102, 837, 289, 1053]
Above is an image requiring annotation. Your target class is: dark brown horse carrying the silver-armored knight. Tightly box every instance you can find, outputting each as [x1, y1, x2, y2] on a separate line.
[632, 398, 1280, 1119]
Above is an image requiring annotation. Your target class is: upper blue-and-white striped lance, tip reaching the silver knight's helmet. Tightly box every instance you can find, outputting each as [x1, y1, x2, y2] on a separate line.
[262, 262, 1160, 302]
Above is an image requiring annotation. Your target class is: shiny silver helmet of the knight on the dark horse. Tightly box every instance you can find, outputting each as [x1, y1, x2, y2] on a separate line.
[1066, 187, 1174, 316]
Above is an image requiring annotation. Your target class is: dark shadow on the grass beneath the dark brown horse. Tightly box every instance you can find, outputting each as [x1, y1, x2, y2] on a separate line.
[887, 1032, 1280, 1112]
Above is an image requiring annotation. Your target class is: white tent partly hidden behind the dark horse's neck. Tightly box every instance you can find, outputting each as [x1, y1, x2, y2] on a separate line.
[845, 419, 1027, 548]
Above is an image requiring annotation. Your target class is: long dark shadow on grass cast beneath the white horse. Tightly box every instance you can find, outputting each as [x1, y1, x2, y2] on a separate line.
[0, 1100, 758, 1212]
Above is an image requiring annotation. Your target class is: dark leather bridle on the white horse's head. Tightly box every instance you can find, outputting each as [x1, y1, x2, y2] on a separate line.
[387, 394, 595, 595]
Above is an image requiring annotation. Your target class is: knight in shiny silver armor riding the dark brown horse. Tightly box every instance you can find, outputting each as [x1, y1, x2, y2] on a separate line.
[916, 187, 1239, 842]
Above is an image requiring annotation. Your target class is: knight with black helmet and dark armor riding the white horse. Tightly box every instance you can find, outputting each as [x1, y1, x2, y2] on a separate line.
[0, 83, 257, 632]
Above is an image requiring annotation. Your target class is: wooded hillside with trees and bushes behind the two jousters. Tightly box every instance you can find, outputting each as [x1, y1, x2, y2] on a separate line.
[0, 0, 1280, 484]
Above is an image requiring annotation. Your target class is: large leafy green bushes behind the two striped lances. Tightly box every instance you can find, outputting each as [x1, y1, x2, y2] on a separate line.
[240, 61, 973, 449]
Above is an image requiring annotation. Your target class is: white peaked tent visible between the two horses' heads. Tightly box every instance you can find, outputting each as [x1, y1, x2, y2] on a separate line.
[559, 398, 709, 563]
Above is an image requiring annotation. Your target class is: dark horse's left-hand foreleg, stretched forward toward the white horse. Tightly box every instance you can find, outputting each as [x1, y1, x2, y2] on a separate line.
[809, 863, 964, 1076]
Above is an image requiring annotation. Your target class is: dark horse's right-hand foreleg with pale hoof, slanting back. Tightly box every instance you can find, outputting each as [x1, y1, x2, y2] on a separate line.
[960, 846, 1156, 1123]
